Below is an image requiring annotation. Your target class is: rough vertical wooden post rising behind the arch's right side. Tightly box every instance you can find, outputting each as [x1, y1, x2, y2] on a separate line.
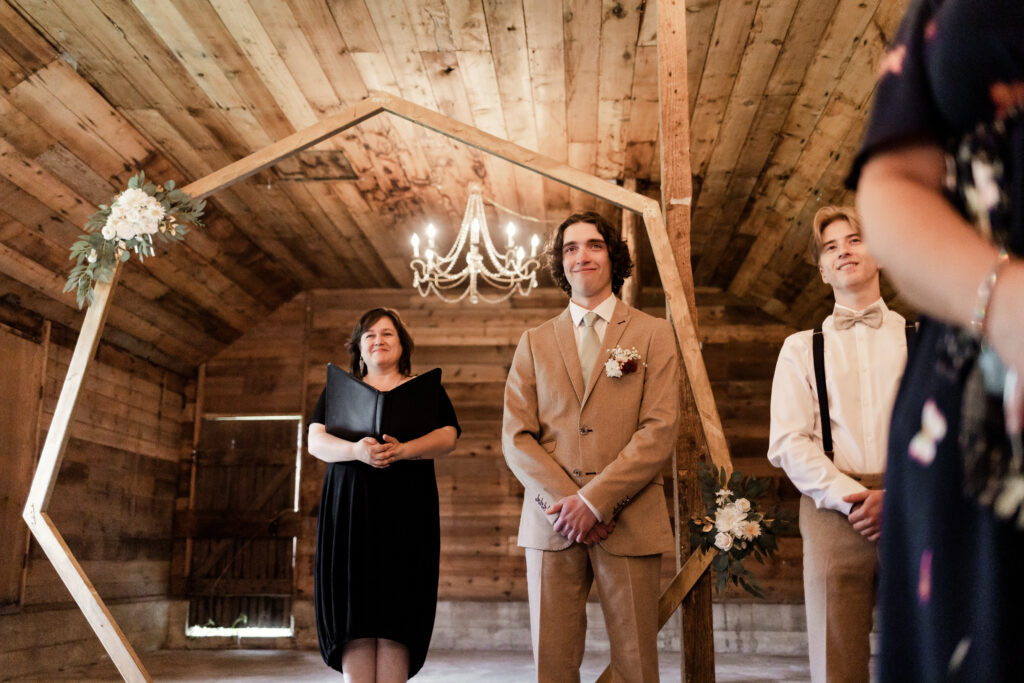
[657, 0, 715, 683]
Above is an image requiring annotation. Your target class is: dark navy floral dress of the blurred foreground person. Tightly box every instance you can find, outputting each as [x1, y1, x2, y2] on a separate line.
[848, 0, 1024, 682]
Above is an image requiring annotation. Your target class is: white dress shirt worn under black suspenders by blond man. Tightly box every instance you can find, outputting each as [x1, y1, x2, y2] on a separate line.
[768, 299, 906, 514]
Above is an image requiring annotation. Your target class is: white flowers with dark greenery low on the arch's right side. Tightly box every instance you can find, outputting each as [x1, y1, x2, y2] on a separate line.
[690, 463, 787, 598]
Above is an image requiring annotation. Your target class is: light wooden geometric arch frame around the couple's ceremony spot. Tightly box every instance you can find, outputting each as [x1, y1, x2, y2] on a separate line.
[22, 92, 732, 681]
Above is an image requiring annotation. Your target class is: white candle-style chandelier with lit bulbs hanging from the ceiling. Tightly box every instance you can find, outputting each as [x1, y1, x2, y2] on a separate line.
[410, 184, 541, 303]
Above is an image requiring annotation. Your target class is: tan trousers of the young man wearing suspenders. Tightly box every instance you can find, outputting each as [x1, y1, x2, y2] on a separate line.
[800, 475, 878, 683]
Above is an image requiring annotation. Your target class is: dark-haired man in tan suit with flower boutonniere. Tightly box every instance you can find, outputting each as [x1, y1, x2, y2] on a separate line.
[502, 212, 679, 682]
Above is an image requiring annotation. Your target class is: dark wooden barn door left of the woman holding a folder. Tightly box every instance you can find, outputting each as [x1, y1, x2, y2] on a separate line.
[176, 417, 300, 628]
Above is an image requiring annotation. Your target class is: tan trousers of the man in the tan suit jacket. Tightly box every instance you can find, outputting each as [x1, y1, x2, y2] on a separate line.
[526, 544, 662, 683]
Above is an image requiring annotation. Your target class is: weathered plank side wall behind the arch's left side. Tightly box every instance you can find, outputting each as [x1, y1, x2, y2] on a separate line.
[0, 326, 186, 676]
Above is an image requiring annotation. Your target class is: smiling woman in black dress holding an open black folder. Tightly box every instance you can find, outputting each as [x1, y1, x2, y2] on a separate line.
[308, 308, 461, 683]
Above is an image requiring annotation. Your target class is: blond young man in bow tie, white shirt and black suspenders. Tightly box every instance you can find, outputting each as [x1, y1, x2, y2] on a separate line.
[768, 207, 907, 683]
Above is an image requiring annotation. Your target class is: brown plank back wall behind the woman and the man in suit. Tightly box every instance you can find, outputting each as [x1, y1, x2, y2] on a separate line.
[204, 290, 802, 602]
